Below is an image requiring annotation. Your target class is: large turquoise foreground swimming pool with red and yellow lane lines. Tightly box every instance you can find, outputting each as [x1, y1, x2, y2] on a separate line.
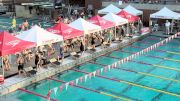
[0, 36, 180, 101]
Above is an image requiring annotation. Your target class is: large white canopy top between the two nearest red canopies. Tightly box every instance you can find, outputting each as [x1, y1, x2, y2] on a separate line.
[16, 25, 63, 46]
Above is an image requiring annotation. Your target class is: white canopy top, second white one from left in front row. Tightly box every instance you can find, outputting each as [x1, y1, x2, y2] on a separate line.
[69, 18, 101, 34]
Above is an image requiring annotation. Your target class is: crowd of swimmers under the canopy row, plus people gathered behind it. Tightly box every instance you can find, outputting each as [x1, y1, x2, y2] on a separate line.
[3, 10, 141, 75]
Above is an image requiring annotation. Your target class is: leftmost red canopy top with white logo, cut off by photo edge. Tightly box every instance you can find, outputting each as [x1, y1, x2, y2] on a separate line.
[0, 32, 35, 56]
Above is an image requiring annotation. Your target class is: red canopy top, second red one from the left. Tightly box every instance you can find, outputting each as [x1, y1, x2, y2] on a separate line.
[47, 22, 84, 40]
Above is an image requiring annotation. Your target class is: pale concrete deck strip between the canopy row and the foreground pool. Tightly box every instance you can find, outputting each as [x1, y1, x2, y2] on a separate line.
[0, 33, 149, 96]
